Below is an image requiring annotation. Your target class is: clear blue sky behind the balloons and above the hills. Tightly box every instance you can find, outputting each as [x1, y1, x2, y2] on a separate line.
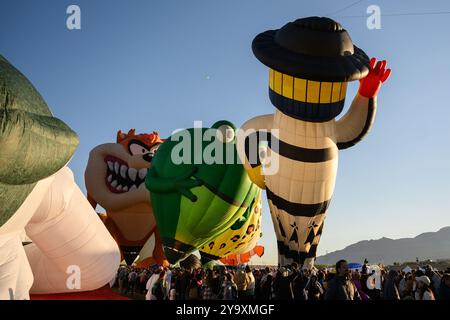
[0, 0, 450, 263]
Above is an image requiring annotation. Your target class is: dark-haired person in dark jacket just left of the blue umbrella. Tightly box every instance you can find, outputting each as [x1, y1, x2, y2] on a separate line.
[325, 260, 361, 300]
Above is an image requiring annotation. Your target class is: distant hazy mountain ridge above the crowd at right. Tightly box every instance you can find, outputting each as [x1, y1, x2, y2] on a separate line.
[316, 227, 450, 265]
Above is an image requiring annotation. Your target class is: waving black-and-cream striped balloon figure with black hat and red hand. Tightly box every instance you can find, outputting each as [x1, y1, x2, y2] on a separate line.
[238, 17, 390, 268]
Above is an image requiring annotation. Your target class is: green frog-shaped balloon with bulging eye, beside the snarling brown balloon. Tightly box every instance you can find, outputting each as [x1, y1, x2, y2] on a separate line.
[145, 121, 258, 264]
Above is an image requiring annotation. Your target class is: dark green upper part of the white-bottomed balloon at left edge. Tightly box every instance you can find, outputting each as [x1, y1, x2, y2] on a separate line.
[0, 55, 78, 226]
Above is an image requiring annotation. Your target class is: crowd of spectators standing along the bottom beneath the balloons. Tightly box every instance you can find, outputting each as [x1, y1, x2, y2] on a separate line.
[115, 260, 450, 300]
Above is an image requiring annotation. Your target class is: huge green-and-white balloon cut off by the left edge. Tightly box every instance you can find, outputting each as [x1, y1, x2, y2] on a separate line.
[0, 56, 120, 299]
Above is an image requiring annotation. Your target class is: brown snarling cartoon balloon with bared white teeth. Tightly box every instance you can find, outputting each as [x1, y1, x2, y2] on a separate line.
[85, 129, 167, 268]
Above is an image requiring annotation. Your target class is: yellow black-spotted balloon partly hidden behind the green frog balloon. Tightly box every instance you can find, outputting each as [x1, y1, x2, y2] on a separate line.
[199, 190, 262, 264]
